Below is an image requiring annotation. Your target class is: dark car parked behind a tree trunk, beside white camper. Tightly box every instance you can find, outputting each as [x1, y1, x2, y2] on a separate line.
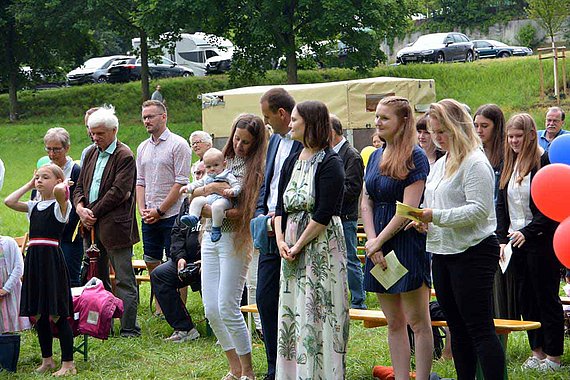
[109, 57, 194, 83]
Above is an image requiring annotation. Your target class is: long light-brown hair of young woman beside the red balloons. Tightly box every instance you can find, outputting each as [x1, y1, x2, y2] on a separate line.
[499, 113, 541, 189]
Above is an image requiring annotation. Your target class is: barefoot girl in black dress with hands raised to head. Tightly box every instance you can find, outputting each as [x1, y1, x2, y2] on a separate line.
[4, 164, 77, 376]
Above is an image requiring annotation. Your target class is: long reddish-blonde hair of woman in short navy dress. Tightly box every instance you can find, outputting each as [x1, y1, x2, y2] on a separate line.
[378, 96, 412, 180]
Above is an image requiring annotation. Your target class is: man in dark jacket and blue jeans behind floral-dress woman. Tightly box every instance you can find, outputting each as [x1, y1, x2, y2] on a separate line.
[331, 115, 366, 309]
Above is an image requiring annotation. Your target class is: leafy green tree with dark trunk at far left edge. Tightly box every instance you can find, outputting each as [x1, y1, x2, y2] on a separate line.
[0, 0, 93, 121]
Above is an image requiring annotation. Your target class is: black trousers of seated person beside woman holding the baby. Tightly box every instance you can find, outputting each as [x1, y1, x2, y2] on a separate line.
[150, 260, 194, 331]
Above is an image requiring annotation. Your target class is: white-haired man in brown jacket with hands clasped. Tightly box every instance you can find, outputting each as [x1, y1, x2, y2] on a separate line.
[73, 107, 140, 337]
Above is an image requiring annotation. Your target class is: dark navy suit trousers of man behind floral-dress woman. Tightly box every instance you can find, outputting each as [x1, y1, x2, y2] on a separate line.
[255, 237, 281, 378]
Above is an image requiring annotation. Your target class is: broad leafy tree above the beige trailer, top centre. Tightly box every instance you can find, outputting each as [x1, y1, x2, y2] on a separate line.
[193, 0, 411, 83]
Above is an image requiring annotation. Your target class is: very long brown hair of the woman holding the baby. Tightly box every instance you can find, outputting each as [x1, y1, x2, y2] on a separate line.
[223, 114, 267, 254]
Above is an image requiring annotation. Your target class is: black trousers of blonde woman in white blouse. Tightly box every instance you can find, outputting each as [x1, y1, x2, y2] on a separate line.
[432, 235, 505, 380]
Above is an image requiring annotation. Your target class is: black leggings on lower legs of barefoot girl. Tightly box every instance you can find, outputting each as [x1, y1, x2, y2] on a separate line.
[36, 314, 73, 362]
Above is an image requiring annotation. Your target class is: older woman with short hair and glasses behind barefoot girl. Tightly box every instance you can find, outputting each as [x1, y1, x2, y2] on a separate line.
[44, 128, 83, 287]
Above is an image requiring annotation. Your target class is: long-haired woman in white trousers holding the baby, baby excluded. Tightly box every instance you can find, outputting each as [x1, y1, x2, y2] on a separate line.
[193, 114, 267, 380]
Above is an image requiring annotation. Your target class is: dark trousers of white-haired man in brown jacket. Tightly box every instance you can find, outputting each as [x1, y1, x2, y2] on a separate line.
[83, 229, 141, 337]
